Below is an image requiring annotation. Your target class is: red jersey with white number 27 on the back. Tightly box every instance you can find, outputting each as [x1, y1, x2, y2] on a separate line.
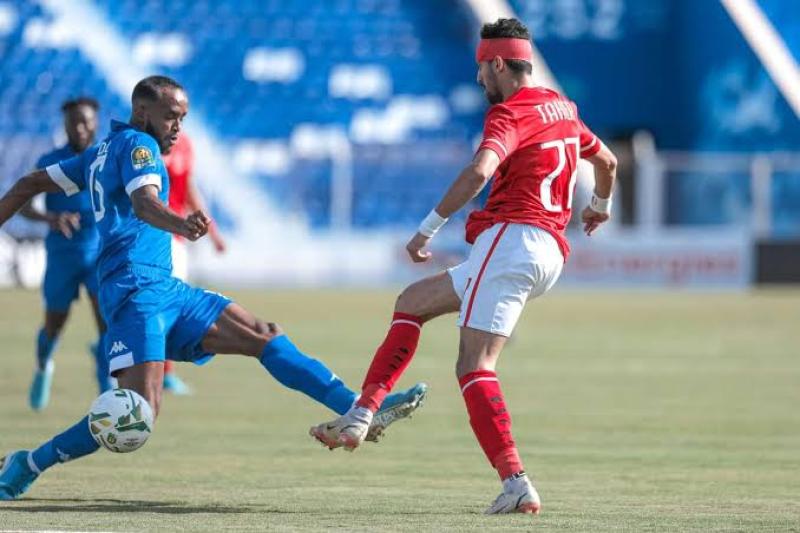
[467, 87, 601, 260]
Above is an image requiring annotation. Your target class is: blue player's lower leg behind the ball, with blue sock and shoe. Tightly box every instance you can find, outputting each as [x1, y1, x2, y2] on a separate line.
[0, 362, 164, 500]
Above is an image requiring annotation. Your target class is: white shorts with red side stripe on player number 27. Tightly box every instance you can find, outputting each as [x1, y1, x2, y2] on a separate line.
[448, 222, 564, 337]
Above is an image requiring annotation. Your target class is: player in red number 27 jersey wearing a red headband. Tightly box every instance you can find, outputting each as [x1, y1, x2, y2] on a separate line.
[311, 19, 616, 514]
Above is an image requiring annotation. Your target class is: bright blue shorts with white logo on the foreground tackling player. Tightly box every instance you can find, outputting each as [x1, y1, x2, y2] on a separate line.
[100, 267, 231, 374]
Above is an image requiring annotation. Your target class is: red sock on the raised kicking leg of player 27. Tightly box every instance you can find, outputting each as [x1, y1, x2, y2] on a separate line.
[356, 313, 422, 412]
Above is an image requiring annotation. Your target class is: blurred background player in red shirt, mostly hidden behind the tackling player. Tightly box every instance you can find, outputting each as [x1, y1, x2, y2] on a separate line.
[163, 133, 225, 395]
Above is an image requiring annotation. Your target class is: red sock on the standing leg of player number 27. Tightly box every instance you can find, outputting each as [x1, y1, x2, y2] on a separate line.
[458, 370, 525, 480]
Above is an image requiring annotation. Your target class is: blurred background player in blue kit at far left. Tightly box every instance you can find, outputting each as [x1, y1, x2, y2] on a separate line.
[20, 97, 111, 411]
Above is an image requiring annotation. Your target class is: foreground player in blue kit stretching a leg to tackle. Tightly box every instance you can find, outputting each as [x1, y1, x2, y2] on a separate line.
[0, 76, 426, 500]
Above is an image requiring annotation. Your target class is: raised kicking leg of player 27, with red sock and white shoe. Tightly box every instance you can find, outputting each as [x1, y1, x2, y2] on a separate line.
[309, 272, 461, 451]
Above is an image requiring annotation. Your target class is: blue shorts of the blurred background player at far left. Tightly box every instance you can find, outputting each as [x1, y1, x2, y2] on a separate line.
[42, 246, 98, 313]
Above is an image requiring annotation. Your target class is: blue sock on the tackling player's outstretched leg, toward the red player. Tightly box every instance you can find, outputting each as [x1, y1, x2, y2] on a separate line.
[260, 335, 356, 415]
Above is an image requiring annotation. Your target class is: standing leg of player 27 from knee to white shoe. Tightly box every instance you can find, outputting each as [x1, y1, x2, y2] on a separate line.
[456, 327, 541, 514]
